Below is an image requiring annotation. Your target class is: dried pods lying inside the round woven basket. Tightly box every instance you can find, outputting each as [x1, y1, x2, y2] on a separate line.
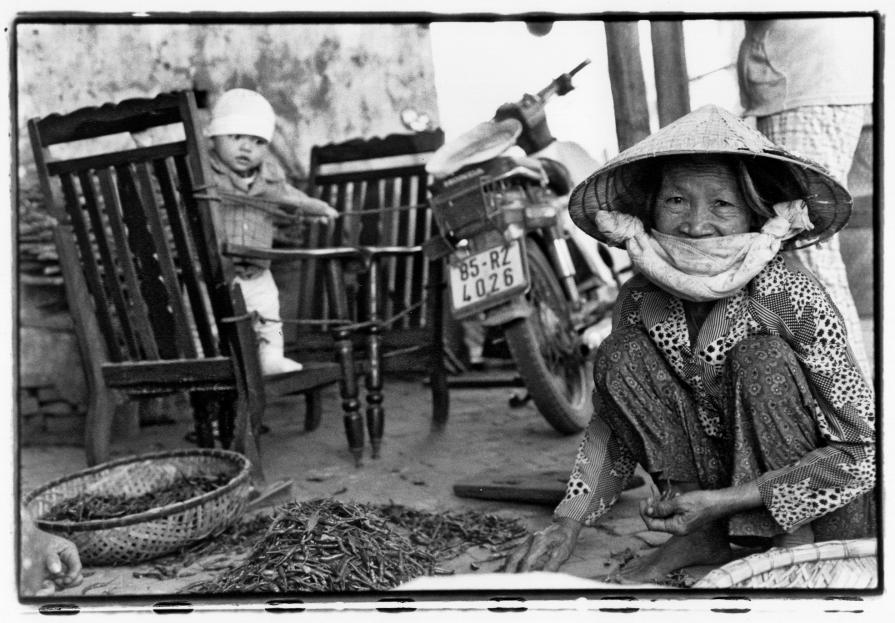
[40, 473, 232, 522]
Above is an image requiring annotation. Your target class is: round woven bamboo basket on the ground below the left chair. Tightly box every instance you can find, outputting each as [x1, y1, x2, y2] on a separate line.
[24, 449, 250, 565]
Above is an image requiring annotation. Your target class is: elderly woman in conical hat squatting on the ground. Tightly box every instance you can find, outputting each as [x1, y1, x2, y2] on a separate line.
[507, 106, 875, 581]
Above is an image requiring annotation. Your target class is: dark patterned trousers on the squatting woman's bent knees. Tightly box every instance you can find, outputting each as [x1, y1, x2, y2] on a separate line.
[594, 327, 873, 541]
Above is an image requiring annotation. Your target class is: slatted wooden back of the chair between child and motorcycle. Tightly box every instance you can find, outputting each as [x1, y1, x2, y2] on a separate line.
[310, 130, 444, 346]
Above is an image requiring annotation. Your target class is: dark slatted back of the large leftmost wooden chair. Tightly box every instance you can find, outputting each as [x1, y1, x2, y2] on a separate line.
[29, 92, 232, 370]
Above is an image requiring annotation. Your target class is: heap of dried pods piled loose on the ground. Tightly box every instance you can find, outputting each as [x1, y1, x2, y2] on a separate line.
[181, 499, 526, 593]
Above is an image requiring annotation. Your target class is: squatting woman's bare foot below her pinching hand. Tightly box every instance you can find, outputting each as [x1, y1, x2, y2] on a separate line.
[616, 525, 732, 584]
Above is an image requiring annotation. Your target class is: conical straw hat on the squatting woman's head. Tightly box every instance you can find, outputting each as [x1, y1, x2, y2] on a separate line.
[569, 105, 852, 248]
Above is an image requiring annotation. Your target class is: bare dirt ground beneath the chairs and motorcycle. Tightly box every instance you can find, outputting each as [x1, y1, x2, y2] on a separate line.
[19, 324, 873, 601]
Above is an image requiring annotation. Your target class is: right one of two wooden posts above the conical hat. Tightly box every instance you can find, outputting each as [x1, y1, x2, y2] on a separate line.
[650, 21, 690, 127]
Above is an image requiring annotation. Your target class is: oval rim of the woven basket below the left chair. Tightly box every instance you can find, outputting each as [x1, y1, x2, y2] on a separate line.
[23, 448, 251, 533]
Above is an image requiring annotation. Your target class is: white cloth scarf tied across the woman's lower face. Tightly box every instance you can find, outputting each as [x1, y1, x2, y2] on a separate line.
[595, 199, 813, 302]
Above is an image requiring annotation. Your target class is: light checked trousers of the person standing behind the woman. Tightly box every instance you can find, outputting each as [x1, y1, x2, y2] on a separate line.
[756, 105, 870, 378]
